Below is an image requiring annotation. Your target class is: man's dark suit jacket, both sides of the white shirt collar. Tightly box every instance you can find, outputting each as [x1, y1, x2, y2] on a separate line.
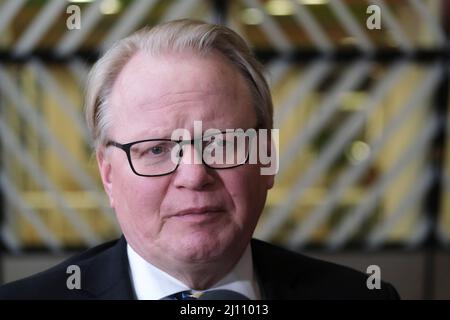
[0, 237, 399, 300]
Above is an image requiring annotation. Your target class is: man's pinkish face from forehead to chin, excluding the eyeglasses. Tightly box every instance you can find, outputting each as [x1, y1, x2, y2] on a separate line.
[98, 53, 273, 267]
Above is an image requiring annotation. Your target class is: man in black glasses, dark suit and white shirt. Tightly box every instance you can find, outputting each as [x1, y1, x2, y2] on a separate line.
[0, 20, 398, 299]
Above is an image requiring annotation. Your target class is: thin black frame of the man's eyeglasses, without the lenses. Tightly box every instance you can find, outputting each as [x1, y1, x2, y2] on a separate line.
[105, 129, 258, 177]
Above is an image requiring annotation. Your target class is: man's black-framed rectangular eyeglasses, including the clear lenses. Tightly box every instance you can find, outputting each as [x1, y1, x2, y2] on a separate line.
[106, 129, 256, 177]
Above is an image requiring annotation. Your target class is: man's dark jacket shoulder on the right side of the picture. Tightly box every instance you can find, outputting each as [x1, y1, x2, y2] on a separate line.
[252, 239, 400, 299]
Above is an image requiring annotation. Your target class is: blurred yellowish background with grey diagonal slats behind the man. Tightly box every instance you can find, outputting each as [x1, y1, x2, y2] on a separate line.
[0, 0, 450, 299]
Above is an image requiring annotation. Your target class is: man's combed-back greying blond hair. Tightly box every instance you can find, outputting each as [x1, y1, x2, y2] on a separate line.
[85, 19, 273, 150]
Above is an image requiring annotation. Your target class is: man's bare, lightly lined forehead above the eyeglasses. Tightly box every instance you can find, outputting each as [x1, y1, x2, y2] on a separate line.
[110, 52, 256, 138]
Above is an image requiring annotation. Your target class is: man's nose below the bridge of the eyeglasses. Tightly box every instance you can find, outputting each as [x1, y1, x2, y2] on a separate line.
[173, 144, 215, 190]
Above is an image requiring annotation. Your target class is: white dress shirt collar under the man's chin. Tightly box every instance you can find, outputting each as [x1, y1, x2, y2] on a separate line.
[127, 244, 261, 300]
